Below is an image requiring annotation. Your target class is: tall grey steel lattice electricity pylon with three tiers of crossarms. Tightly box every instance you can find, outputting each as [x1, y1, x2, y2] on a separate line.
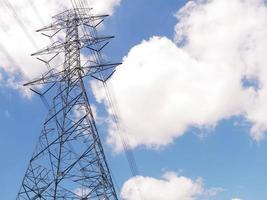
[17, 8, 120, 200]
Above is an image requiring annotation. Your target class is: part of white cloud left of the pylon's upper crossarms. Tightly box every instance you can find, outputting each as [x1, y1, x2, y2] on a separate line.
[0, 0, 66, 91]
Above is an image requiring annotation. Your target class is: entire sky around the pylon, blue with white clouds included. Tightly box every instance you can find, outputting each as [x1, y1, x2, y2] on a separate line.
[0, 0, 267, 200]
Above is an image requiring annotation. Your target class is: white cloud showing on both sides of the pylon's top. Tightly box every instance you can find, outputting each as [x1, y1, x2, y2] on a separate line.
[0, 0, 120, 95]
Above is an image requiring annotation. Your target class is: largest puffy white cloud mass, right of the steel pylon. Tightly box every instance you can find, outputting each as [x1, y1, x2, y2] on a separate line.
[93, 0, 267, 151]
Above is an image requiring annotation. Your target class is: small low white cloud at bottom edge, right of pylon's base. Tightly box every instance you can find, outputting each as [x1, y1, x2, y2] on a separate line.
[121, 172, 220, 200]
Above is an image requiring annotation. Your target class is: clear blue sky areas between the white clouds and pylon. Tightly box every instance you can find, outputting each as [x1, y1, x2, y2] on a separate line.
[0, 0, 267, 200]
